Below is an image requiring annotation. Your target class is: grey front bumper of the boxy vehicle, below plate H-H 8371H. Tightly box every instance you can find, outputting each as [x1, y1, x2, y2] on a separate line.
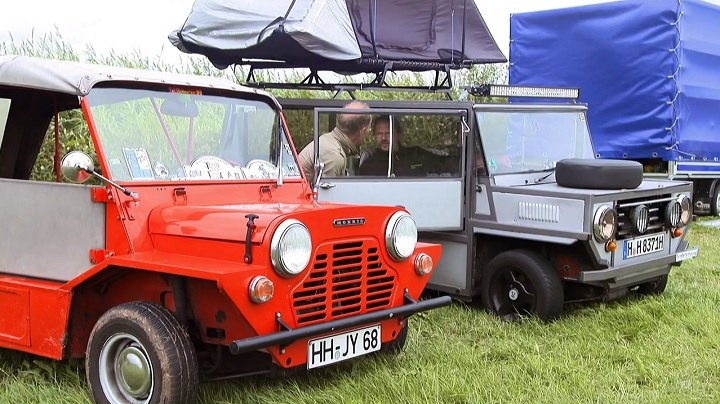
[578, 240, 699, 287]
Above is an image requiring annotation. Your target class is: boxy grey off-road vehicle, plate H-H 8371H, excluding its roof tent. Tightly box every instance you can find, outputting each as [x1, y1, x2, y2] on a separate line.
[280, 86, 698, 320]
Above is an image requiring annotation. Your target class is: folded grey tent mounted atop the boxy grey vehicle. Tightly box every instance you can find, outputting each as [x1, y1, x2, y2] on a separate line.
[169, 0, 507, 89]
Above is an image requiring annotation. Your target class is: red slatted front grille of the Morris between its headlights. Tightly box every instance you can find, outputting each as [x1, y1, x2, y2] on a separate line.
[292, 240, 395, 325]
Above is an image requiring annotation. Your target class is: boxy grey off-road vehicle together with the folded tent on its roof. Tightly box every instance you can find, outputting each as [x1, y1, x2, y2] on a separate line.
[170, 0, 698, 320]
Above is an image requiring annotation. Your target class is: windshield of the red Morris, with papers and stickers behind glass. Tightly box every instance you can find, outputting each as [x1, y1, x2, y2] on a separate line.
[87, 88, 300, 181]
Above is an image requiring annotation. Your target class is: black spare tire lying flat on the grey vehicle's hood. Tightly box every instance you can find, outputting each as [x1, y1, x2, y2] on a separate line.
[555, 159, 643, 189]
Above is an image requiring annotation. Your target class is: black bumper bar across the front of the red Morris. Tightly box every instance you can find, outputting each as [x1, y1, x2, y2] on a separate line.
[229, 295, 452, 354]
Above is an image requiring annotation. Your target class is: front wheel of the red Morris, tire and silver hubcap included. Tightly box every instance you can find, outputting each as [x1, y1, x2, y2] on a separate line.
[85, 302, 199, 404]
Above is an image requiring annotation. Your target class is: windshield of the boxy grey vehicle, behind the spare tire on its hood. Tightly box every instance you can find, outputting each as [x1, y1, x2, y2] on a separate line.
[476, 110, 594, 175]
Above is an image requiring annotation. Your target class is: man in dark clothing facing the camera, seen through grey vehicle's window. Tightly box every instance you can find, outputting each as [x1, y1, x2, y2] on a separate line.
[358, 115, 443, 177]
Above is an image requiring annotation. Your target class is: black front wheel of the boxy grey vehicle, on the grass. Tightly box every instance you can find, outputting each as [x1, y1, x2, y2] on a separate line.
[481, 250, 565, 321]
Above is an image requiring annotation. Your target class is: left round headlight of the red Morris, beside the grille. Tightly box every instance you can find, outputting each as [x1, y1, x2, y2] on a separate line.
[270, 219, 312, 277]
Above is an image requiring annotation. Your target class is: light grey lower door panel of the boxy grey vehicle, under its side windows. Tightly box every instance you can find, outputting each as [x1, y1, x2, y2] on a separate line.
[318, 178, 463, 231]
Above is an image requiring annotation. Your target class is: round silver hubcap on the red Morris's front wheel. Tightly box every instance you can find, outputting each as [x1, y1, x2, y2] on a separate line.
[115, 344, 152, 398]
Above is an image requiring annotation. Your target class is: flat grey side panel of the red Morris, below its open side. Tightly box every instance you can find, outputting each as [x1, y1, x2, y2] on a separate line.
[0, 179, 105, 281]
